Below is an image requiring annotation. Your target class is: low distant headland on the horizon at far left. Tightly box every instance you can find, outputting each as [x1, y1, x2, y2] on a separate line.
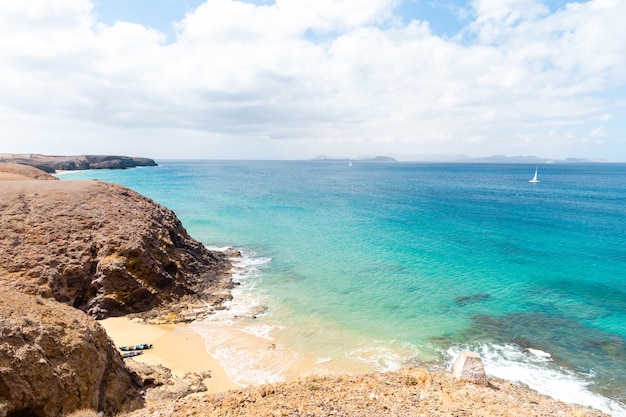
[0, 153, 157, 173]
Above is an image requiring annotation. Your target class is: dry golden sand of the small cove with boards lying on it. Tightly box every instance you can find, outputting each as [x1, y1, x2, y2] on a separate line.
[99, 317, 241, 393]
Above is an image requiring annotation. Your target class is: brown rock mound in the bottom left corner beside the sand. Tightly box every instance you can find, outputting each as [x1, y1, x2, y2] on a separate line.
[0, 287, 143, 417]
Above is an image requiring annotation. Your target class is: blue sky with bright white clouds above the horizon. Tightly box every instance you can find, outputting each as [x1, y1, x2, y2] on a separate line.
[0, 0, 626, 162]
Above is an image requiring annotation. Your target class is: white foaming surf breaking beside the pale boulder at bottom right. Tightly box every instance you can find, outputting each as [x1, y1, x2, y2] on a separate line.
[446, 344, 626, 417]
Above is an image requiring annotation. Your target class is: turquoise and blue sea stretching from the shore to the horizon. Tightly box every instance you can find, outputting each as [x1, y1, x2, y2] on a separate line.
[61, 161, 626, 416]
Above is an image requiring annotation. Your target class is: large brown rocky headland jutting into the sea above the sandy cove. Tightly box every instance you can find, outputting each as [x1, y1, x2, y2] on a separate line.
[0, 181, 232, 318]
